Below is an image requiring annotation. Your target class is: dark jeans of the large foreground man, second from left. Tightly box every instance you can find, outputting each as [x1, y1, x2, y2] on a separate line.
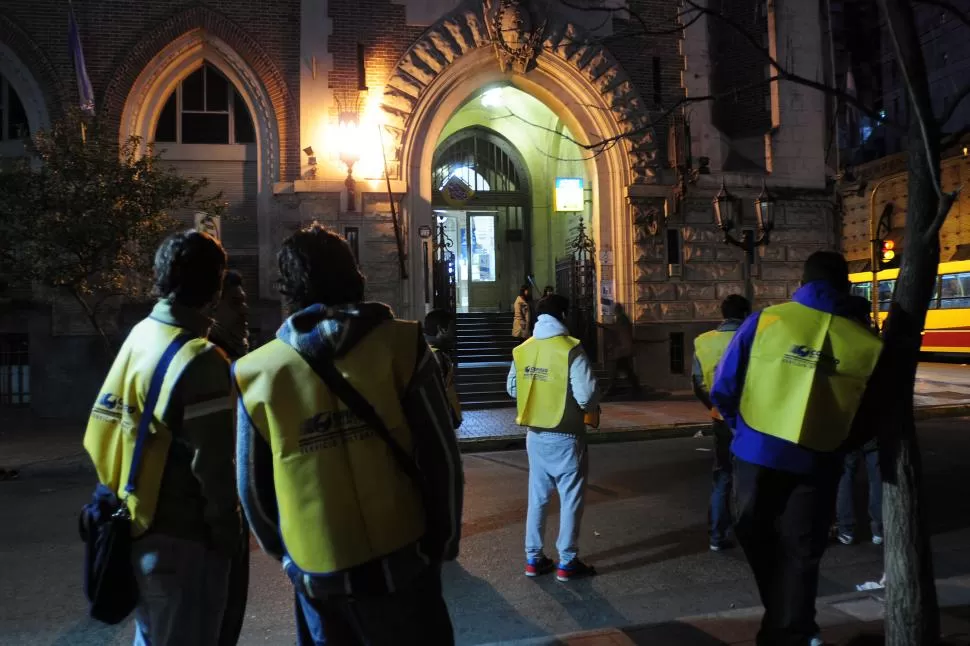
[296, 565, 455, 646]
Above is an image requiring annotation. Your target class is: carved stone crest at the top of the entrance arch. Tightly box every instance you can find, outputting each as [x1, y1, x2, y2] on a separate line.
[482, 0, 546, 74]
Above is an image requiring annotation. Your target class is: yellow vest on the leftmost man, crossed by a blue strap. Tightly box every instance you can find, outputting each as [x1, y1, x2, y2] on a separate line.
[84, 318, 214, 536]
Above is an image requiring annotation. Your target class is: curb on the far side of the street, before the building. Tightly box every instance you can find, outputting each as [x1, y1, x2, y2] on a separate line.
[458, 404, 970, 453]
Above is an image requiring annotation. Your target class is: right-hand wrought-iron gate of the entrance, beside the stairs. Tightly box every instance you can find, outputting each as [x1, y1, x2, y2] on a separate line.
[556, 216, 598, 361]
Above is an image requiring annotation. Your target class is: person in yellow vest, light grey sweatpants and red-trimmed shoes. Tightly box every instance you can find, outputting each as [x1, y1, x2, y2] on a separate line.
[506, 295, 600, 582]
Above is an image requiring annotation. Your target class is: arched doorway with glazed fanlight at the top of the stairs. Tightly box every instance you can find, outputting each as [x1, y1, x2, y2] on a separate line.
[432, 126, 532, 312]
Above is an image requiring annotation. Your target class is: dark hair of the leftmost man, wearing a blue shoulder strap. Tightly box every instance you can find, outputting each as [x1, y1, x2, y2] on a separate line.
[153, 229, 226, 308]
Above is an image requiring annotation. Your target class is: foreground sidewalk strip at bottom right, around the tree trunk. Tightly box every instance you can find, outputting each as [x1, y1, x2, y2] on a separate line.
[486, 577, 970, 646]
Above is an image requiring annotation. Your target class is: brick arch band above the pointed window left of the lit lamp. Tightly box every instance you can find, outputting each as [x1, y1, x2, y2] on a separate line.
[102, 6, 300, 181]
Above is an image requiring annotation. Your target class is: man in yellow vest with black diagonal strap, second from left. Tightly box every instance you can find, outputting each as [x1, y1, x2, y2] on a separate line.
[233, 225, 463, 646]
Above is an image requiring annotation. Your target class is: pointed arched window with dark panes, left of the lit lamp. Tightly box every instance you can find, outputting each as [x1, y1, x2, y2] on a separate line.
[155, 63, 256, 144]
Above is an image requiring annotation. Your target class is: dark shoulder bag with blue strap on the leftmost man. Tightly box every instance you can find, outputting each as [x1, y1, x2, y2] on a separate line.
[78, 334, 195, 624]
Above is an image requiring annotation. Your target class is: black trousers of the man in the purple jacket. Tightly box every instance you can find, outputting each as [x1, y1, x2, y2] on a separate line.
[734, 457, 840, 646]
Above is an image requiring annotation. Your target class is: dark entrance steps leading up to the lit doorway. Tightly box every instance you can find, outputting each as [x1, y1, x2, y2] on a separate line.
[455, 312, 516, 410]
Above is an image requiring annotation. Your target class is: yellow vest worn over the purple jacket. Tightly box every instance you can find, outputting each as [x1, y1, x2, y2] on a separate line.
[741, 302, 882, 451]
